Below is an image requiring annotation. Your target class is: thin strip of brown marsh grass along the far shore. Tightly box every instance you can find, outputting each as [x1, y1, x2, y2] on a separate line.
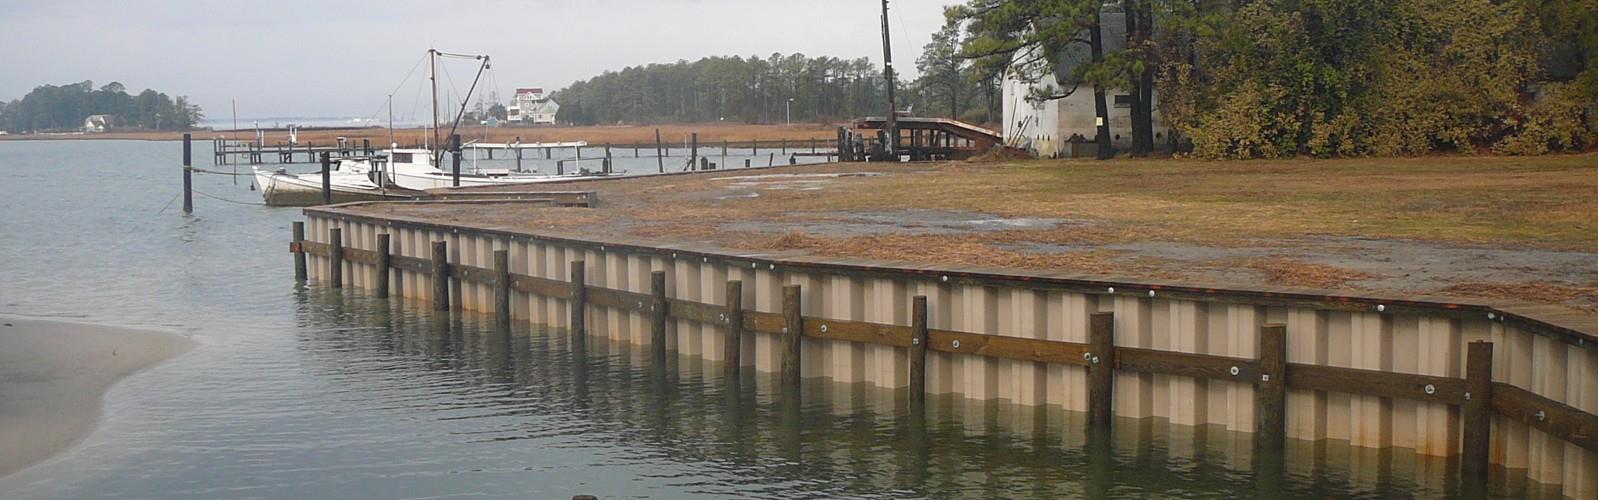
[0, 123, 837, 145]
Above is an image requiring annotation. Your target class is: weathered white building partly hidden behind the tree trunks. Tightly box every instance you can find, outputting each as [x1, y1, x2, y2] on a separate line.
[1002, 11, 1168, 157]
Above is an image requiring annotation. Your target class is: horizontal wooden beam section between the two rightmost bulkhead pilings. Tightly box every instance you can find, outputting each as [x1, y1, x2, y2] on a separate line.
[1288, 363, 1465, 404]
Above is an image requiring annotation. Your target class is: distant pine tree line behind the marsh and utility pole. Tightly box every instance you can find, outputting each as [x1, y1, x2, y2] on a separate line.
[551, 54, 999, 125]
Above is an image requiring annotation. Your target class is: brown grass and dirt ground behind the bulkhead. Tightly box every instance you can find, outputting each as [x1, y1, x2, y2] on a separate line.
[349, 155, 1598, 312]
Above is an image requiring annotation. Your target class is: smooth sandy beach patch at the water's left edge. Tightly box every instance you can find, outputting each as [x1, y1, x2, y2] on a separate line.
[0, 316, 193, 476]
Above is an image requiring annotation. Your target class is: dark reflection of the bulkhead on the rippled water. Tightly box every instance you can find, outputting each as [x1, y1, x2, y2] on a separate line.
[299, 289, 1446, 498]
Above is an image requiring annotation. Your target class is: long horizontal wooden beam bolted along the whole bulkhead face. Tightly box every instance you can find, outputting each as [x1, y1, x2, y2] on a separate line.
[289, 233, 1598, 456]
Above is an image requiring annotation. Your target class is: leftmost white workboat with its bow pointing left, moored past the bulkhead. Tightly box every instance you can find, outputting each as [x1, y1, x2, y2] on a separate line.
[254, 158, 422, 206]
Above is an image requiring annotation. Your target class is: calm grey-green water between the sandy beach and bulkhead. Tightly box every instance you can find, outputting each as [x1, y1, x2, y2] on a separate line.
[0, 141, 1470, 498]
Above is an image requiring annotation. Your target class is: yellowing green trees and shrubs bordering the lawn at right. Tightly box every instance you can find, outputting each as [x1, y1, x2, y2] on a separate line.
[943, 0, 1598, 158]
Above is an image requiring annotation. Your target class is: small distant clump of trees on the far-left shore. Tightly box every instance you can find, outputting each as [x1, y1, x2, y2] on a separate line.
[0, 80, 205, 134]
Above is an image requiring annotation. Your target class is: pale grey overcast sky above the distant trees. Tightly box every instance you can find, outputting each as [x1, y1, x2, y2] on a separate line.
[0, 0, 957, 120]
